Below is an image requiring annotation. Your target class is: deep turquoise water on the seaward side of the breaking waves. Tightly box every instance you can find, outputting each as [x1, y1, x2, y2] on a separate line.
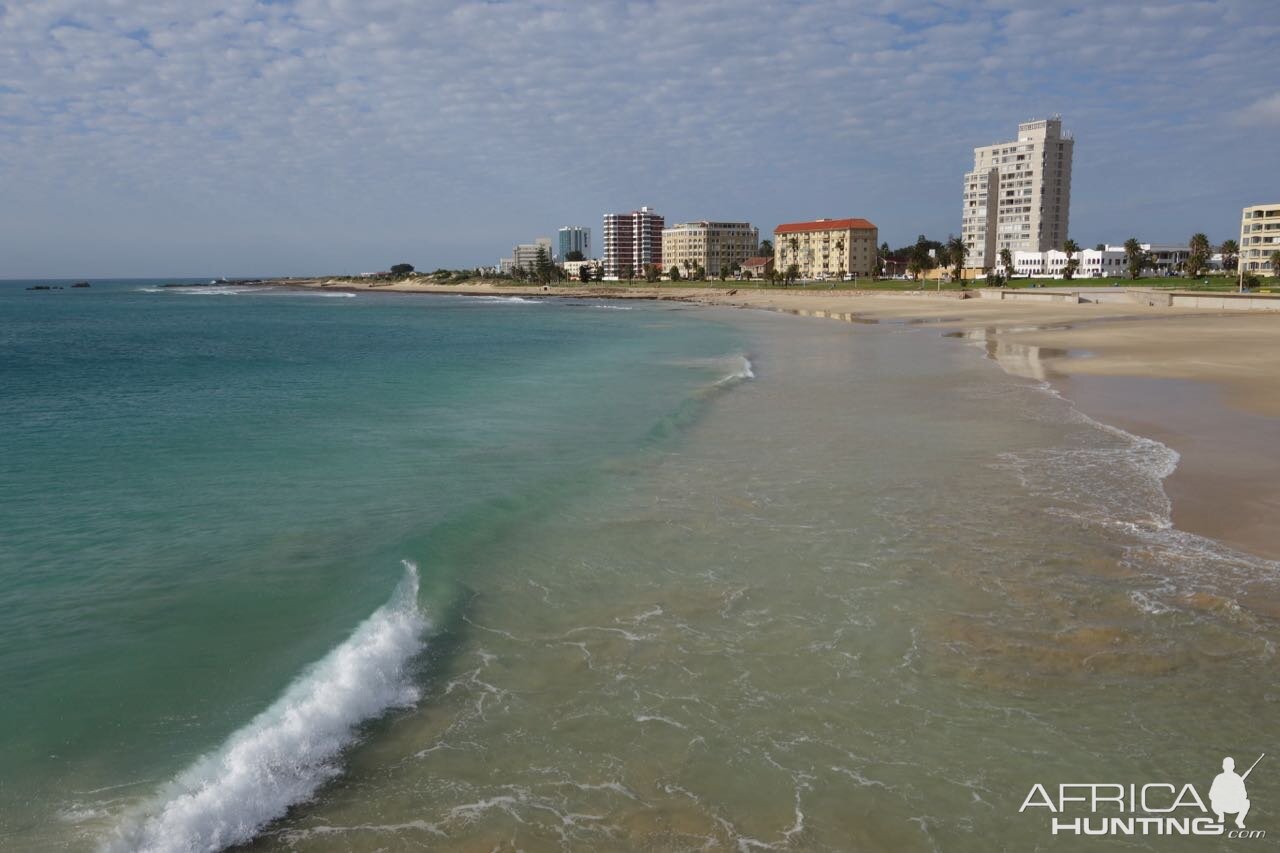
[0, 282, 741, 839]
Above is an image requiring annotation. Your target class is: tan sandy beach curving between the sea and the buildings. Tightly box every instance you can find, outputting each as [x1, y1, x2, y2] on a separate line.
[264, 279, 1280, 560]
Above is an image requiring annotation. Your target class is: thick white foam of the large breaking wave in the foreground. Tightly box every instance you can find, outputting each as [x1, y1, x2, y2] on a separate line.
[101, 561, 426, 853]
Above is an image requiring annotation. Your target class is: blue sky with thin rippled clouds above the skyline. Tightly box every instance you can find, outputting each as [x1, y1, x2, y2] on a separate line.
[0, 0, 1280, 278]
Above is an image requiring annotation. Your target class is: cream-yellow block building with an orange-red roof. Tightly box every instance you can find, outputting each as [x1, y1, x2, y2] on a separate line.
[773, 219, 879, 279]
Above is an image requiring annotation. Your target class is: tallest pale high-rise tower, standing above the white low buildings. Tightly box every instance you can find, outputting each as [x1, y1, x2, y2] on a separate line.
[960, 117, 1075, 269]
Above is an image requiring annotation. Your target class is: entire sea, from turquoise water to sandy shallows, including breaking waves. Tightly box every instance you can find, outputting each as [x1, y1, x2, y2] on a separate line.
[0, 282, 1280, 850]
